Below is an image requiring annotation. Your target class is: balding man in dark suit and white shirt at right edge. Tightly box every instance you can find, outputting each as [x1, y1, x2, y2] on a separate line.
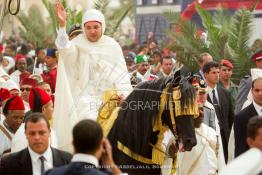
[234, 78, 262, 157]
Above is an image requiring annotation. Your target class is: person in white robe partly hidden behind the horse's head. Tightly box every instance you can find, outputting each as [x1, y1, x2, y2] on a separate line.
[176, 108, 225, 175]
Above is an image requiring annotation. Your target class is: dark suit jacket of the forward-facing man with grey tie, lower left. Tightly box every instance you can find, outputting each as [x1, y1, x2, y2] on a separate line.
[0, 148, 72, 175]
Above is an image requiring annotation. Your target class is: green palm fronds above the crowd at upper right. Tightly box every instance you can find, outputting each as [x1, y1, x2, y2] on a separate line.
[164, 6, 261, 81]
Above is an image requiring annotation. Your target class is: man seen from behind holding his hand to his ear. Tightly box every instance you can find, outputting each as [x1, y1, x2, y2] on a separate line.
[46, 119, 121, 175]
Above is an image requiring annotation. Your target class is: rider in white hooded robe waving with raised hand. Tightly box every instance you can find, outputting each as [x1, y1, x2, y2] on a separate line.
[54, 0, 132, 149]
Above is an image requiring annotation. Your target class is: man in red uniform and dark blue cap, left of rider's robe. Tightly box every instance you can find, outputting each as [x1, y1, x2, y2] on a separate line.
[42, 48, 58, 93]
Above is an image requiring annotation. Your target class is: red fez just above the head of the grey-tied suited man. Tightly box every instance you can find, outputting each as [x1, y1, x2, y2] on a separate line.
[29, 87, 52, 111]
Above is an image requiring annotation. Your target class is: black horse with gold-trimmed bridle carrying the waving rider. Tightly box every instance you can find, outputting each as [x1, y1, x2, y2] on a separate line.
[103, 74, 196, 175]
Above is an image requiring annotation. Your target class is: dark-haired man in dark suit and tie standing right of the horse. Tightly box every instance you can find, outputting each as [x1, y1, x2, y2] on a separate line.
[203, 61, 234, 162]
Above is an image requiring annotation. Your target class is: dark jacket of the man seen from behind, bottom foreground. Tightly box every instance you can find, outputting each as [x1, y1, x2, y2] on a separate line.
[45, 162, 106, 175]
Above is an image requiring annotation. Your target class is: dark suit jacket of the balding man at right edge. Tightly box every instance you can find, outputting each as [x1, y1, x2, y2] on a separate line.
[234, 103, 258, 157]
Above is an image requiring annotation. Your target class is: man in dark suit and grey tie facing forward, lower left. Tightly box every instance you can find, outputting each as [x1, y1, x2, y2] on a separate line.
[0, 113, 72, 175]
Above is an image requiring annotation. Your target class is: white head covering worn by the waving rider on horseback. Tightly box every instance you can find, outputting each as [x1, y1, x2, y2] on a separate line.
[82, 9, 106, 34]
